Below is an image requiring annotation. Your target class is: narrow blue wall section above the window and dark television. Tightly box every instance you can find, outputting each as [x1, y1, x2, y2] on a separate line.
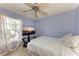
[0, 8, 34, 26]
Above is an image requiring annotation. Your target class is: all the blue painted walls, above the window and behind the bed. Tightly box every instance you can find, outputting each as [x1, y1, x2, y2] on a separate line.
[0, 7, 79, 37]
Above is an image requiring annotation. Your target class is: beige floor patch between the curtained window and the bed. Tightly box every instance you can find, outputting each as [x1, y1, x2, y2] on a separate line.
[6, 47, 28, 56]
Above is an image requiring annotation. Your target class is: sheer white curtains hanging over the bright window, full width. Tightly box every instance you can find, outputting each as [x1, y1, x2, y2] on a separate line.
[0, 15, 22, 49]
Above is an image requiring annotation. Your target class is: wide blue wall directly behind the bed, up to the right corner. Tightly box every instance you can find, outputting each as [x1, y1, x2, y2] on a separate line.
[35, 10, 76, 37]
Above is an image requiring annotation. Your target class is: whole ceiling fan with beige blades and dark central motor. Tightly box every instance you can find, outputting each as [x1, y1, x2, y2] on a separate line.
[23, 3, 47, 18]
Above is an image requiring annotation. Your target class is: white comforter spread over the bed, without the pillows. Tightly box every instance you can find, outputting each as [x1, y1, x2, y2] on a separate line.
[27, 36, 79, 56]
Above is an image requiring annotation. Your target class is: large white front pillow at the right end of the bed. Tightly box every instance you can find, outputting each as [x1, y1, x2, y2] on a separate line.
[63, 36, 79, 48]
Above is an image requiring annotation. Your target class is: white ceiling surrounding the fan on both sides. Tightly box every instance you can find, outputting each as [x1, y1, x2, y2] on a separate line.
[0, 3, 79, 18]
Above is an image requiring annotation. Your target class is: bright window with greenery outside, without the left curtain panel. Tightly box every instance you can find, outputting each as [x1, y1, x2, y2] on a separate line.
[4, 17, 21, 43]
